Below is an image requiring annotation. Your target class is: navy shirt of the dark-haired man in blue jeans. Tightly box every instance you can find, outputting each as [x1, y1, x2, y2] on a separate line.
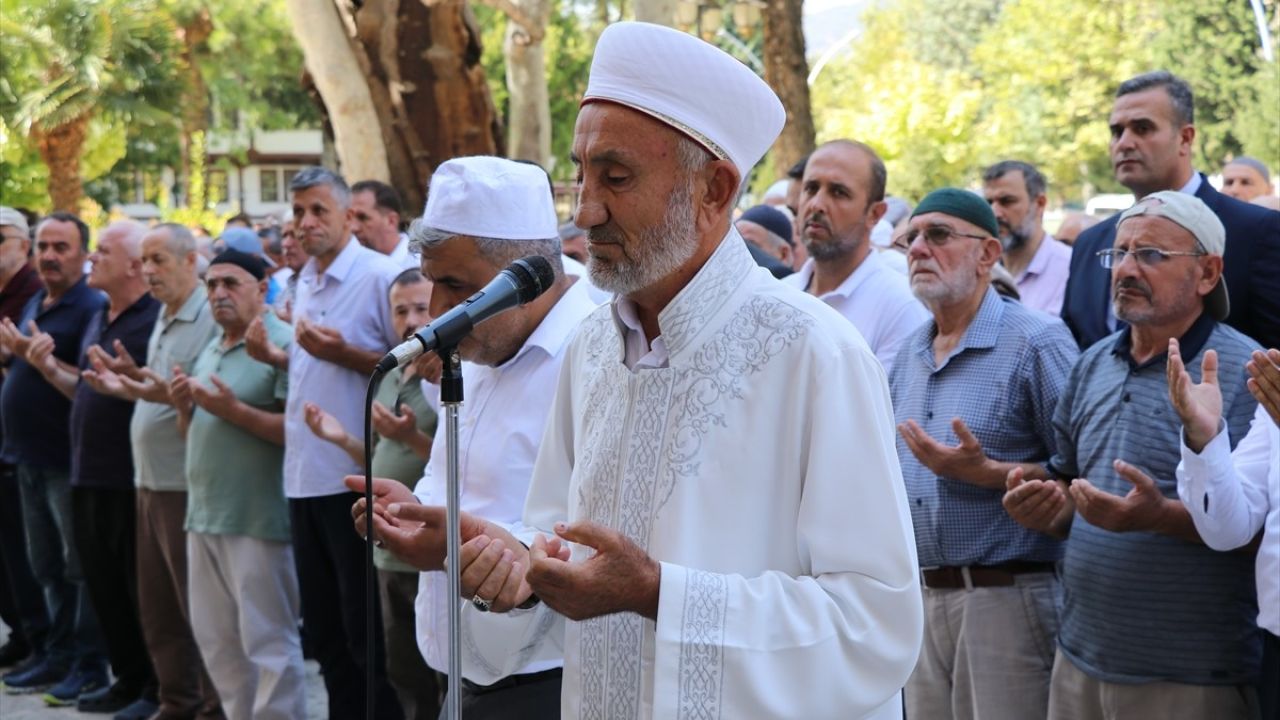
[0, 278, 106, 470]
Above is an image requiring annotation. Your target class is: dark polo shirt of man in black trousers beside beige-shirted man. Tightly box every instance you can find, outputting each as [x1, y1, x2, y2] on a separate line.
[70, 293, 160, 488]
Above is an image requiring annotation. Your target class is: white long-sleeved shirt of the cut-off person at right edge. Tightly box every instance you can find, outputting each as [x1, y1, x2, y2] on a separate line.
[1178, 405, 1280, 635]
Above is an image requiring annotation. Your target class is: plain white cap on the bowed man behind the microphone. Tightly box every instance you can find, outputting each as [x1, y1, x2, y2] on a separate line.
[422, 155, 559, 240]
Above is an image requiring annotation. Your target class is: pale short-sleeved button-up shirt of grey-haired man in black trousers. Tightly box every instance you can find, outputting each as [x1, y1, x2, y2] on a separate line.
[284, 237, 401, 498]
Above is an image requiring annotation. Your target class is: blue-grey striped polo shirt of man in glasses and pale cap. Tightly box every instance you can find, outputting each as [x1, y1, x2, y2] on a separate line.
[1051, 314, 1261, 685]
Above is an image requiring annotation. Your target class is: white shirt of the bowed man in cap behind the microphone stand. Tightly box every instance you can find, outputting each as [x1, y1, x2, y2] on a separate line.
[413, 274, 596, 671]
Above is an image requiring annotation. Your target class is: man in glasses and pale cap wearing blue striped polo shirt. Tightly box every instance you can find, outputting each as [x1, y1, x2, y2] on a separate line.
[1005, 191, 1261, 720]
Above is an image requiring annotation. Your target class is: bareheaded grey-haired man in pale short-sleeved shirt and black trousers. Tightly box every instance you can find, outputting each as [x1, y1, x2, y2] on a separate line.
[244, 167, 401, 719]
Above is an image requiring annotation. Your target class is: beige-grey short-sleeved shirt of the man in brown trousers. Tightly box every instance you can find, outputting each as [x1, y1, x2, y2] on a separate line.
[129, 284, 218, 491]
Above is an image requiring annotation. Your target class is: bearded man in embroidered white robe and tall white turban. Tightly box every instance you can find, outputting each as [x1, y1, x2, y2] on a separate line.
[371, 23, 922, 719]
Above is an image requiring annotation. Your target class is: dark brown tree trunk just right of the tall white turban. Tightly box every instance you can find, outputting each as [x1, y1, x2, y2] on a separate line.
[764, 0, 814, 178]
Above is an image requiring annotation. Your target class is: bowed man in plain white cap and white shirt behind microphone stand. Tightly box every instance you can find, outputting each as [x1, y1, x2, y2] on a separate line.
[348, 156, 596, 720]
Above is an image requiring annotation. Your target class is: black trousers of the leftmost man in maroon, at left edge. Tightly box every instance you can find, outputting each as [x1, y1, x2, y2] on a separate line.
[0, 465, 49, 652]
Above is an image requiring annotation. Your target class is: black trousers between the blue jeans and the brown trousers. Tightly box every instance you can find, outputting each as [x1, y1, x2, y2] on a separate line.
[72, 486, 156, 694]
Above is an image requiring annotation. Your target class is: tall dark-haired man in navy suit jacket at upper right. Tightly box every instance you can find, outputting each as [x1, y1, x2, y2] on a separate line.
[1062, 70, 1280, 350]
